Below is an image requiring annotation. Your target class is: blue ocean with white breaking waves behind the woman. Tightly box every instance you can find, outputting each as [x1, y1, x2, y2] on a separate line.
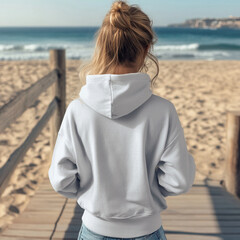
[0, 27, 240, 60]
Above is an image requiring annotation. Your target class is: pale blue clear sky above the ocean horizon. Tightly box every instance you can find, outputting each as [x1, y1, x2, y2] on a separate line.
[0, 0, 240, 27]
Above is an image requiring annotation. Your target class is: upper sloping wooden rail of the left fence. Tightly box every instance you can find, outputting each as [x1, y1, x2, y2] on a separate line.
[0, 69, 58, 132]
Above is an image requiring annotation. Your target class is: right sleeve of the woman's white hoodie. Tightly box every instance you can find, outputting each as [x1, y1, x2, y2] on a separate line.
[157, 104, 196, 197]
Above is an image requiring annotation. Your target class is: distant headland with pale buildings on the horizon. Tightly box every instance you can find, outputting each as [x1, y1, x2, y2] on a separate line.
[168, 16, 240, 29]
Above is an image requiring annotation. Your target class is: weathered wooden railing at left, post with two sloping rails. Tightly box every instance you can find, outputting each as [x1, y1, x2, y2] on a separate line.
[0, 49, 66, 199]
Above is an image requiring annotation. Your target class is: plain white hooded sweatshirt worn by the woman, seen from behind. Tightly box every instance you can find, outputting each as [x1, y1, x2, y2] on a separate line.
[48, 72, 195, 238]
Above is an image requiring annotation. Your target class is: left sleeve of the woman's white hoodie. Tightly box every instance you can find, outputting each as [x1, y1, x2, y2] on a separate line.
[48, 132, 80, 198]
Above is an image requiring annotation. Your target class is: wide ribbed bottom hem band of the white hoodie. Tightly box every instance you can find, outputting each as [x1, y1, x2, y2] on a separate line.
[82, 210, 162, 238]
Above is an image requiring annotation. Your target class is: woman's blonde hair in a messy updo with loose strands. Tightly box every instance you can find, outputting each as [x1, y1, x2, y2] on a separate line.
[79, 1, 159, 88]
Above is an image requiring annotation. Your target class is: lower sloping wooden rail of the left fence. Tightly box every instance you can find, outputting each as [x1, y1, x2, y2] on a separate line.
[0, 98, 57, 196]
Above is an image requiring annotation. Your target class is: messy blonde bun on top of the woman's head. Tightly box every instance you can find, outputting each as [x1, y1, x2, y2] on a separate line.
[110, 1, 131, 30]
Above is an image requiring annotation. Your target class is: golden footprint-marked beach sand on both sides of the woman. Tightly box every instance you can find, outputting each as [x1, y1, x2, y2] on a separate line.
[0, 60, 240, 231]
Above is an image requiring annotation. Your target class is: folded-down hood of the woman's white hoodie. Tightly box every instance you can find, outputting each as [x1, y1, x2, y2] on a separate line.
[79, 72, 152, 119]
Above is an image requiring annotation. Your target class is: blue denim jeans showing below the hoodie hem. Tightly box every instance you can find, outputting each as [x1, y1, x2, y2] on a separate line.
[77, 223, 167, 240]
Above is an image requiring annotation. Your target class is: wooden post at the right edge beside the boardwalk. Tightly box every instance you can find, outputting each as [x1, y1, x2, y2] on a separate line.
[224, 111, 240, 198]
